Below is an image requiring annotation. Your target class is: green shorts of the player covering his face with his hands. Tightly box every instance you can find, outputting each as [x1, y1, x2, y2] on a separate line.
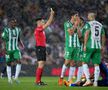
[64, 47, 80, 61]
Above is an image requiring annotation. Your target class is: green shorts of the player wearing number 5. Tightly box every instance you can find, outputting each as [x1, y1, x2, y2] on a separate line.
[82, 49, 101, 64]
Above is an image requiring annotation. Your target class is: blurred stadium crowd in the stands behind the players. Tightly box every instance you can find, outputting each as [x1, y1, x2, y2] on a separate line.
[0, 0, 108, 65]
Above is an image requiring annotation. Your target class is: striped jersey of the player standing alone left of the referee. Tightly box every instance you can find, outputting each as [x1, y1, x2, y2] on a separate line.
[2, 27, 21, 51]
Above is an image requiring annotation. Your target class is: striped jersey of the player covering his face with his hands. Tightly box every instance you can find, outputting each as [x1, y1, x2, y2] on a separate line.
[64, 21, 80, 47]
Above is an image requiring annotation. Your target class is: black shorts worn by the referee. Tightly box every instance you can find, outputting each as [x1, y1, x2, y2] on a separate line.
[36, 46, 46, 61]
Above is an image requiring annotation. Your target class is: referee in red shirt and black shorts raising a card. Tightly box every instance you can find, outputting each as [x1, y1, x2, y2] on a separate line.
[34, 8, 54, 86]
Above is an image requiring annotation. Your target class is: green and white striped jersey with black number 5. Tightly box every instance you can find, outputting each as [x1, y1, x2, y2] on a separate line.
[85, 20, 105, 49]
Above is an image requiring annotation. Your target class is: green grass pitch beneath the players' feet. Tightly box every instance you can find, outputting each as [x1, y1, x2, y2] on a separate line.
[0, 77, 108, 90]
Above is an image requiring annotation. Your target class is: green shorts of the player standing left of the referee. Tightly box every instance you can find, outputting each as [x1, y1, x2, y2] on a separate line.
[5, 50, 21, 63]
